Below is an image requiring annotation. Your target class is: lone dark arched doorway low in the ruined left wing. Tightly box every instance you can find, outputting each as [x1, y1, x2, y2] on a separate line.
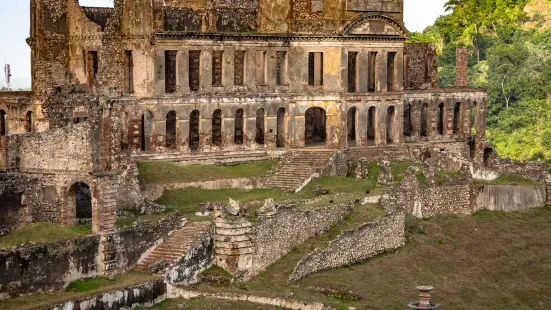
[66, 182, 92, 225]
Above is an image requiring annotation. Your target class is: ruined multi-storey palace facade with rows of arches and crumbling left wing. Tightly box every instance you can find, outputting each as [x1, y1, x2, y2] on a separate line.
[0, 0, 487, 231]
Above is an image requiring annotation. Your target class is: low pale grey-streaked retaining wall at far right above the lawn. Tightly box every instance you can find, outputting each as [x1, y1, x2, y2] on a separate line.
[475, 185, 547, 211]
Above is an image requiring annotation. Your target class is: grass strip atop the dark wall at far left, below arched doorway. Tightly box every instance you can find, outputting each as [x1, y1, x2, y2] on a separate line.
[0, 223, 92, 248]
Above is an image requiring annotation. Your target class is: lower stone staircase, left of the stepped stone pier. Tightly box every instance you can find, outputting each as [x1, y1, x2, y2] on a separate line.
[136, 222, 212, 271]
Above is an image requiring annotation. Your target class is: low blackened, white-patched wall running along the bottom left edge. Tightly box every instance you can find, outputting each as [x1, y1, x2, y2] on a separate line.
[42, 280, 167, 310]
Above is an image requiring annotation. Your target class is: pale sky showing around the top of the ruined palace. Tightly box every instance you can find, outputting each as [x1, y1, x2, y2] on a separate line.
[0, 0, 446, 89]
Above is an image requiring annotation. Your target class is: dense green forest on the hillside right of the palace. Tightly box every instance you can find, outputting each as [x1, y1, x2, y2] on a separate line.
[411, 0, 551, 164]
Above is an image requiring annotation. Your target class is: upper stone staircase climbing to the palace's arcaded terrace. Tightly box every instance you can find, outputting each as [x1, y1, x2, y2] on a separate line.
[265, 150, 334, 191]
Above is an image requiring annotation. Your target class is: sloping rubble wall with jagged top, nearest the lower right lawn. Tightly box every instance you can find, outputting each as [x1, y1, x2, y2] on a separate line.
[289, 209, 406, 282]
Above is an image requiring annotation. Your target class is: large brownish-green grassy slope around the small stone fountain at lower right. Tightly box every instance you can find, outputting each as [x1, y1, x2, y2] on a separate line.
[191, 207, 551, 309]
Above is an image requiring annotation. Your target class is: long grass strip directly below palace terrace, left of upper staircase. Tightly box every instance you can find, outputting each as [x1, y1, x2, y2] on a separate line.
[137, 160, 276, 184]
